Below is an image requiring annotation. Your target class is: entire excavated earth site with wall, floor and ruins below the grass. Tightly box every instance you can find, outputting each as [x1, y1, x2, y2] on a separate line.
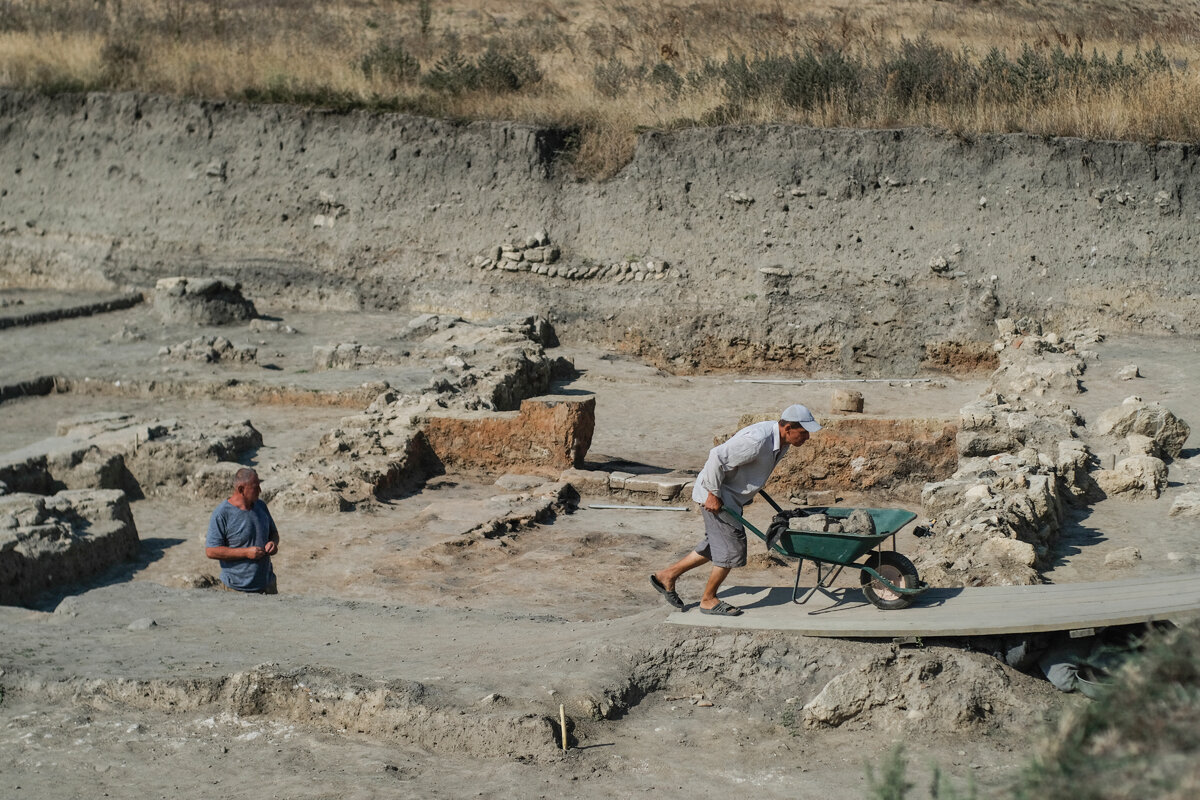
[0, 95, 1200, 798]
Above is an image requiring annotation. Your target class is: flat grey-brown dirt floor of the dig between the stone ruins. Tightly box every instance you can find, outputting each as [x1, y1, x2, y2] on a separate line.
[0, 300, 1200, 798]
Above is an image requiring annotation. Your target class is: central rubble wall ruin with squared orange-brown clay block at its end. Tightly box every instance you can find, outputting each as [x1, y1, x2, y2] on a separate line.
[264, 315, 576, 511]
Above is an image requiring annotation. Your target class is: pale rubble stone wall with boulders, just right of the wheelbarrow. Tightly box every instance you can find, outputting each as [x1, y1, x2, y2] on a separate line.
[914, 319, 1189, 585]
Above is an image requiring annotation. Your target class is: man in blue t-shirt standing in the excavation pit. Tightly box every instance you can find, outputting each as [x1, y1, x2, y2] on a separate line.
[204, 468, 280, 595]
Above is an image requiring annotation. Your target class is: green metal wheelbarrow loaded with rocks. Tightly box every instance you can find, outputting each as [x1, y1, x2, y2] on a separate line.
[722, 492, 929, 609]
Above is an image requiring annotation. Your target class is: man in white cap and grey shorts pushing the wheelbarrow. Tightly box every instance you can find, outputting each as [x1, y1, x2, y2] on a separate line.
[650, 405, 821, 616]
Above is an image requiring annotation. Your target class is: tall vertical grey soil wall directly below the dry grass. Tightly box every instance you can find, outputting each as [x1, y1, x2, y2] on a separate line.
[0, 92, 1200, 375]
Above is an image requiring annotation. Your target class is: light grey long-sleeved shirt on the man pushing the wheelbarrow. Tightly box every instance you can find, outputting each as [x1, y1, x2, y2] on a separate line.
[691, 420, 788, 513]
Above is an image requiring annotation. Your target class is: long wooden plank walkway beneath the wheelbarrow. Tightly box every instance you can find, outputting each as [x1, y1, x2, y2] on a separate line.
[666, 573, 1200, 638]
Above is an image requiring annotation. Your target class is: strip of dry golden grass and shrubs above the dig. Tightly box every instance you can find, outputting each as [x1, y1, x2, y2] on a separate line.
[0, 0, 1200, 176]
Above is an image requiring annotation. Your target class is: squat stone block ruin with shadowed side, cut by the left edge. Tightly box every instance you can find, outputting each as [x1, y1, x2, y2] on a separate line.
[0, 489, 139, 604]
